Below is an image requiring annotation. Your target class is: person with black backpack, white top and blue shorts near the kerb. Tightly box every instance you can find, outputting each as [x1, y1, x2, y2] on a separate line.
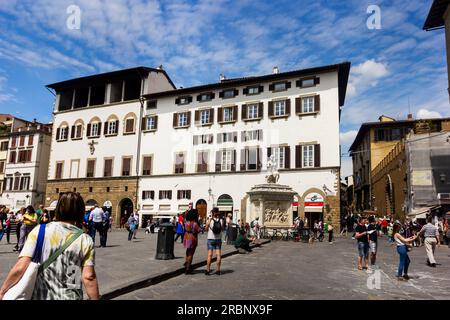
[205, 207, 224, 275]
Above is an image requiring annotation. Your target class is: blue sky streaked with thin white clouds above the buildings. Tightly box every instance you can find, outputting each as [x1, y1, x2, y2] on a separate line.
[0, 0, 450, 175]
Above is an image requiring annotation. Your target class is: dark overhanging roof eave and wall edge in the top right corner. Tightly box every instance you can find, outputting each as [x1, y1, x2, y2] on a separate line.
[423, 0, 450, 101]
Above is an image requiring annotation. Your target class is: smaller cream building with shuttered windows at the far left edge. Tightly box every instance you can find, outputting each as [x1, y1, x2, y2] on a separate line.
[0, 119, 52, 211]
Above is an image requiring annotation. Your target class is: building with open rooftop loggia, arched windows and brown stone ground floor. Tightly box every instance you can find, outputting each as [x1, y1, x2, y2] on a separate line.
[46, 67, 175, 224]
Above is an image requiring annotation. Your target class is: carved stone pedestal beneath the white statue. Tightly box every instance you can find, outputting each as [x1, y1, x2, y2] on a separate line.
[247, 183, 296, 228]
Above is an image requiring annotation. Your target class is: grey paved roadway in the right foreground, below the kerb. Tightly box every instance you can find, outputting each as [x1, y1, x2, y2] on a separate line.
[118, 237, 450, 300]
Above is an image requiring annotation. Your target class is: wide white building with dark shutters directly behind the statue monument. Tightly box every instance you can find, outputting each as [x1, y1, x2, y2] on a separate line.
[139, 63, 350, 226]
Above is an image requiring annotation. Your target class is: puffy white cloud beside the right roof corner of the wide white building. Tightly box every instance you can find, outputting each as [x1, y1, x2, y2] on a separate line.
[348, 59, 389, 97]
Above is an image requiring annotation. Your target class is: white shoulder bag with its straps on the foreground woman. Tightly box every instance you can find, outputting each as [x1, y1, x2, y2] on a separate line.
[3, 224, 83, 300]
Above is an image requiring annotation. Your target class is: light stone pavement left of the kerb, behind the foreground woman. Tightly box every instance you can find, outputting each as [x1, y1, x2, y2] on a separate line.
[0, 229, 235, 294]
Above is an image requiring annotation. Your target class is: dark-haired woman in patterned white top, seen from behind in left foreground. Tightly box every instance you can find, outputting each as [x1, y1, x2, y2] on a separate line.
[0, 192, 99, 300]
